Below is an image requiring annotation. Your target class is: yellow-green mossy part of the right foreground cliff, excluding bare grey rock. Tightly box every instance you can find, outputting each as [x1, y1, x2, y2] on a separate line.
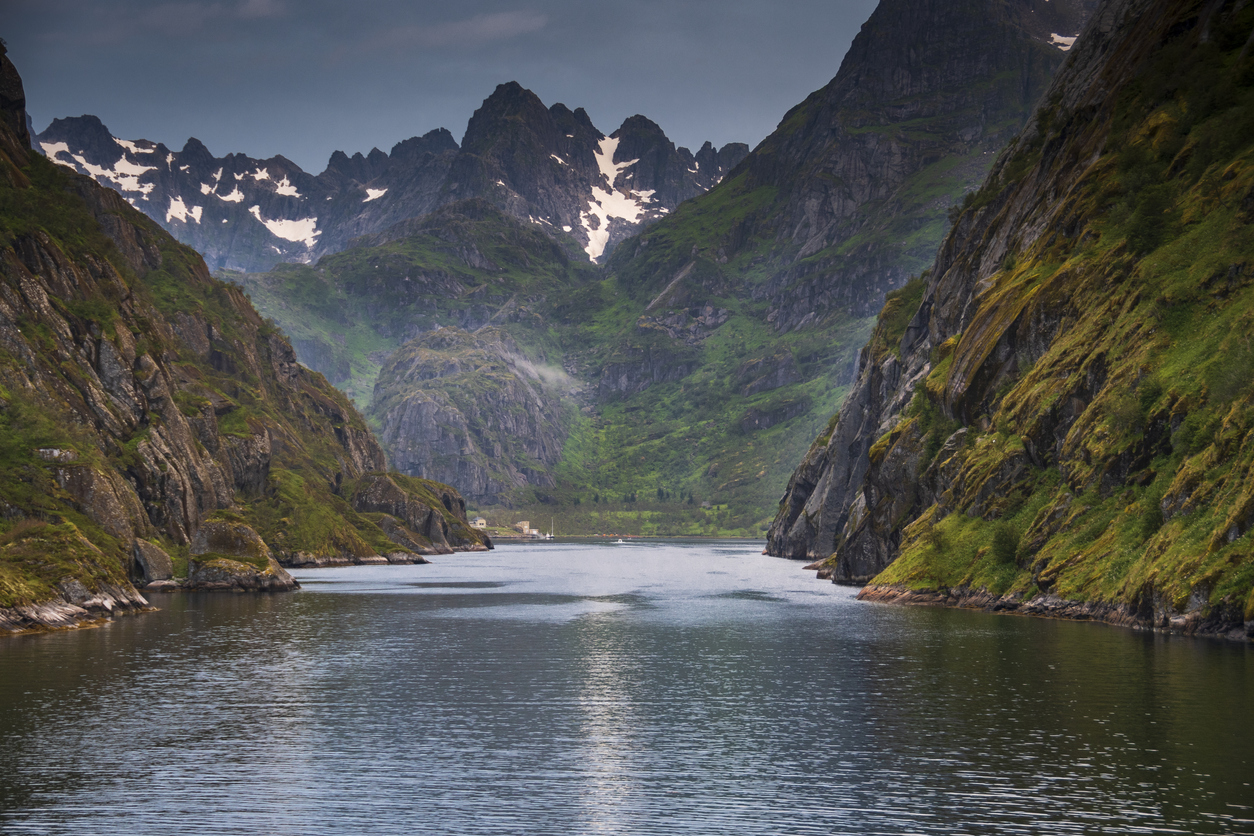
[847, 4, 1254, 623]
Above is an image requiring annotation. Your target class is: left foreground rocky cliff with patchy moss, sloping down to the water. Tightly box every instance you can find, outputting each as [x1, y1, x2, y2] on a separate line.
[0, 49, 483, 628]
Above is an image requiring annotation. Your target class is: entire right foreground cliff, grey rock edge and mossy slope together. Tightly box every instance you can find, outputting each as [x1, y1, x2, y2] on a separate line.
[770, 0, 1254, 634]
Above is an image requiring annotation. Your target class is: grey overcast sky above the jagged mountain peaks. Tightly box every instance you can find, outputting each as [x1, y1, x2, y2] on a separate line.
[0, 0, 875, 174]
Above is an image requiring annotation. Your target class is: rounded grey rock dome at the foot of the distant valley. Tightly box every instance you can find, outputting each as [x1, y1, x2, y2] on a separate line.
[371, 326, 569, 505]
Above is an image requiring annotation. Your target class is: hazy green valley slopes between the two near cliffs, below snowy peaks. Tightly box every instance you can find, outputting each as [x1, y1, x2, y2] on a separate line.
[220, 0, 1092, 535]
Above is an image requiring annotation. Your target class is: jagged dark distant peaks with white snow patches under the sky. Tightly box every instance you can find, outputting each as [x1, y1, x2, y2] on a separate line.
[35, 83, 749, 271]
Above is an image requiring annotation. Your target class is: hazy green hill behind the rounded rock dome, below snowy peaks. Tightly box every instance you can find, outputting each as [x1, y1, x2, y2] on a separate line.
[235, 199, 599, 409]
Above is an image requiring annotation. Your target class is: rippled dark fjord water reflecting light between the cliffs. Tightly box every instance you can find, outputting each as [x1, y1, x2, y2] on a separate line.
[0, 541, 1254, 833]
